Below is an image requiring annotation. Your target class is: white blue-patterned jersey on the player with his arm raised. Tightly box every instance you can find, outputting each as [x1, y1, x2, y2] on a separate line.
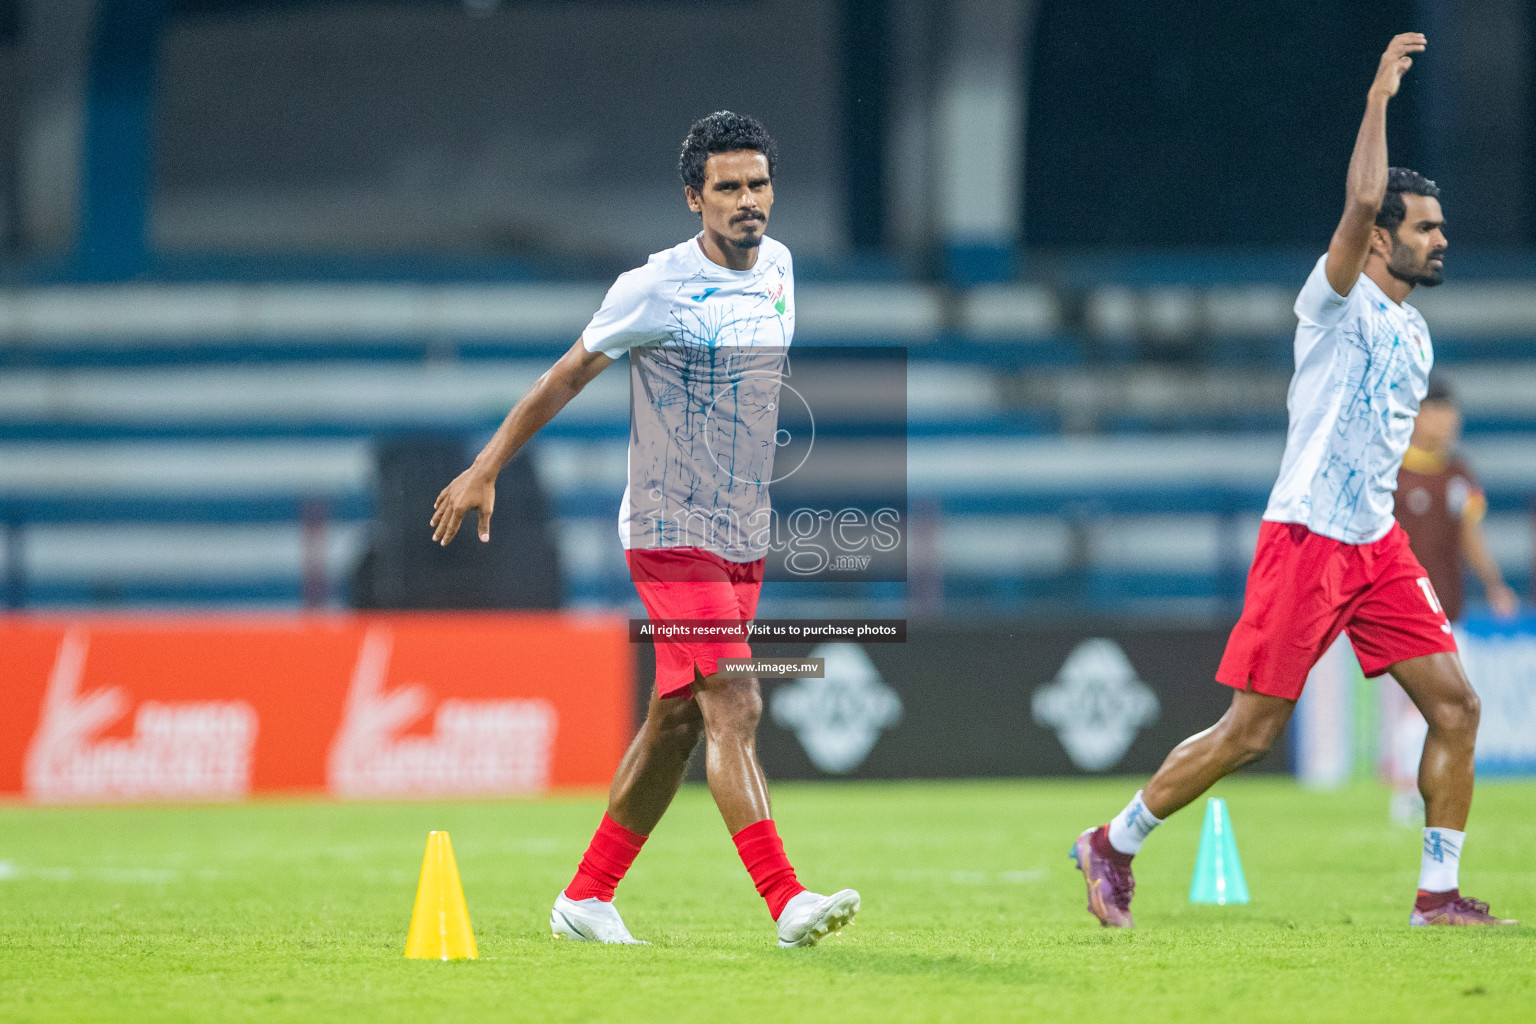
[1264, 256, 1435, 543]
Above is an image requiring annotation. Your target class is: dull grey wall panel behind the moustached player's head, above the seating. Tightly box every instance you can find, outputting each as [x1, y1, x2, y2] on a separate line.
[154, 0, 842, 264]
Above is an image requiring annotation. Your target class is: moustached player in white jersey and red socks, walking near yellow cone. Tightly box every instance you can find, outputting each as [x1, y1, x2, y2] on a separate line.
[432, 111, 859, 946]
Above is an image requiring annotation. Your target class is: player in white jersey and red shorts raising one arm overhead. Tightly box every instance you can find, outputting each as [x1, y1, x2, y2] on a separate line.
[1072, 32, 1510, 927]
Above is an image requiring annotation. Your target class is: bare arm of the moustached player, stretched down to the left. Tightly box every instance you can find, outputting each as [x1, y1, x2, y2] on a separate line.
[432, 338, 613, 545]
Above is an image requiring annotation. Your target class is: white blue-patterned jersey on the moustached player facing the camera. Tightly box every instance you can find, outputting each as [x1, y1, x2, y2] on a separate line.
[582, 236, 794, 562]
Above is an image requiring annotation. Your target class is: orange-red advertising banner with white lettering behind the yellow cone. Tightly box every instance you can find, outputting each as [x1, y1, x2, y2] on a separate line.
[0, 614, 634, 801]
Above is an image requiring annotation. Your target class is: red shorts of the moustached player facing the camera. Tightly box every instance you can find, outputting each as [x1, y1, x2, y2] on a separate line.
[624, 548, 763, 697]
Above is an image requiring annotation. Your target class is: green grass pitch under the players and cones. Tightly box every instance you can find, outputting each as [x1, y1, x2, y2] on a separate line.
[0, 778, 1536, 1024]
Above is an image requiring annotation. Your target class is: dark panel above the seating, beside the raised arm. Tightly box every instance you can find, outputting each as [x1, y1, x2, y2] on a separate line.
[1025, 0, 1436, 249]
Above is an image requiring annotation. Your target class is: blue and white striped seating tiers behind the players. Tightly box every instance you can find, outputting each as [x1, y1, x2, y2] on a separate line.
[0, 275, 1536, 614]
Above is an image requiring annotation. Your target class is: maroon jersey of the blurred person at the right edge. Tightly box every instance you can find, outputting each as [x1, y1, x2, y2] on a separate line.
[1395, 447, 1488, 622]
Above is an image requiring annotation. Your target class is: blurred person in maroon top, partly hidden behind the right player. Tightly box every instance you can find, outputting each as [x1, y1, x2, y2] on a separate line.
[1382, 373, 1519, 824]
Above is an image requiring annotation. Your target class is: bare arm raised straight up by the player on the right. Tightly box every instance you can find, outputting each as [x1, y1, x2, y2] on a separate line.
[1326, 32, 1428, 295]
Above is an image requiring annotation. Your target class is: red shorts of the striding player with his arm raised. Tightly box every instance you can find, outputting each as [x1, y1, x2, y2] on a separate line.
[1217, 520, 1456, 700]
